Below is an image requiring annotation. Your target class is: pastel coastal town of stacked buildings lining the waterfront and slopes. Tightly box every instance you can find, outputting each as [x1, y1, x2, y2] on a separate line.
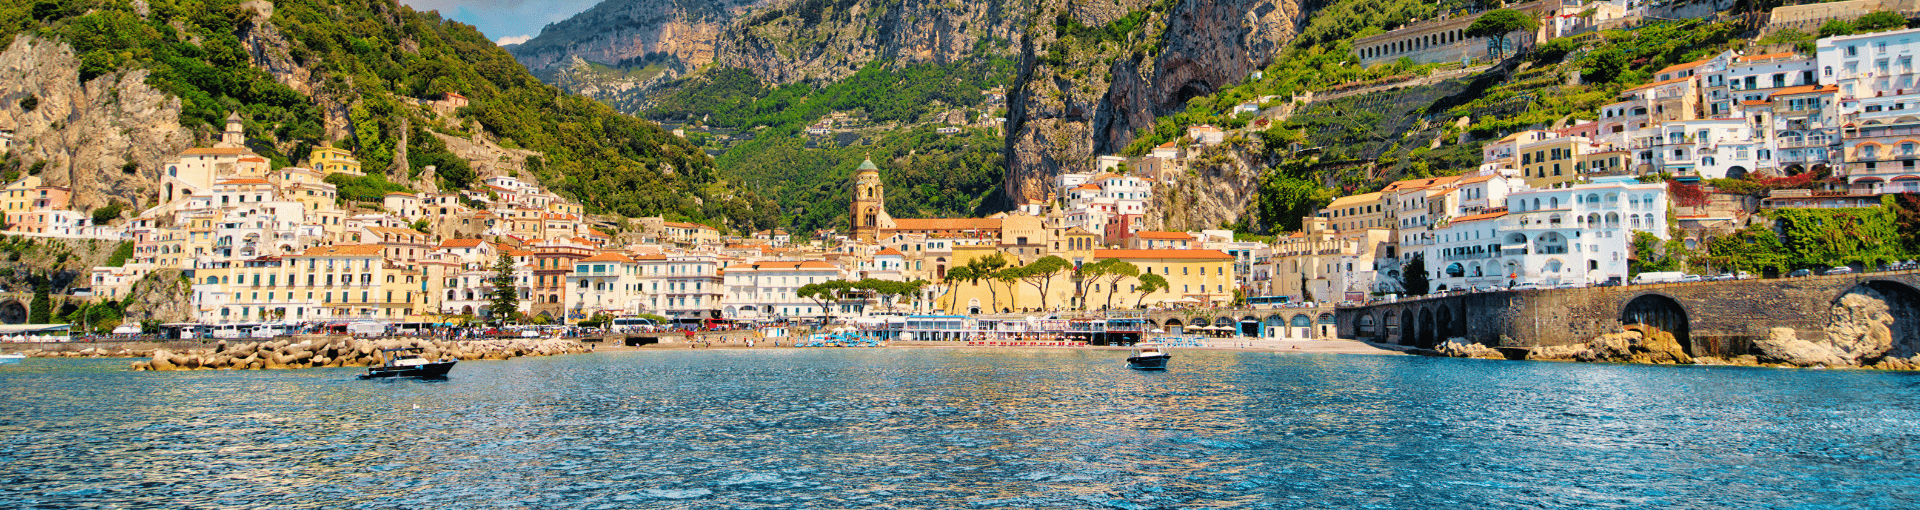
[0, 24, 1873, 335]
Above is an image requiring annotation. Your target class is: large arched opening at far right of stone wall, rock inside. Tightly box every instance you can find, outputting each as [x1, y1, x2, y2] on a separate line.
[1826, 280, 1920, 364]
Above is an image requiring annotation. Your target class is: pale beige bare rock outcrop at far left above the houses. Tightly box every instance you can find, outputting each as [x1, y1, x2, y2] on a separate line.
[0, 35, 194, 209]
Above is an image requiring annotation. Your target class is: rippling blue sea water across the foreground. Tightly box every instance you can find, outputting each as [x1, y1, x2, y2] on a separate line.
[0, 349, 1920, 510]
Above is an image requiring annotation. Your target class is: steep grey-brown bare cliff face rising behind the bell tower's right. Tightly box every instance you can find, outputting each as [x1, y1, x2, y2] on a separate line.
[1004, 0, 1304, 207]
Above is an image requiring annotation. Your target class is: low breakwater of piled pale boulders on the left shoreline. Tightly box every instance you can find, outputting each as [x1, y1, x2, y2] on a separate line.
[132, 337, 591, 370]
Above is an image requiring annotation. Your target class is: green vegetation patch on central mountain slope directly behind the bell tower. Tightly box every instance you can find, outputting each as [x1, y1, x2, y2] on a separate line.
[647, 56, 1014, 232]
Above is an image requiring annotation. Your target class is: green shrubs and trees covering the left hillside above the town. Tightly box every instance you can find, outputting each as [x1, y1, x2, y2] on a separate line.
[0, 0, 772, 228]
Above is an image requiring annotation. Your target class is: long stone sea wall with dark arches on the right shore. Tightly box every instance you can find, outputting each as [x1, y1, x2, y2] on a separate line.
[1336, 270, 1920, 357]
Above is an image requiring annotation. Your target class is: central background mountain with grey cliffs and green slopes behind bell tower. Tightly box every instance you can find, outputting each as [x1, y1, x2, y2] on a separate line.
[515, 0, 1306, 230]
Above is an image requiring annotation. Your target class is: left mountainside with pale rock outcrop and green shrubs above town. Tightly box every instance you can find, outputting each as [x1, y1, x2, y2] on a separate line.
[0, 0, 776, 230]
